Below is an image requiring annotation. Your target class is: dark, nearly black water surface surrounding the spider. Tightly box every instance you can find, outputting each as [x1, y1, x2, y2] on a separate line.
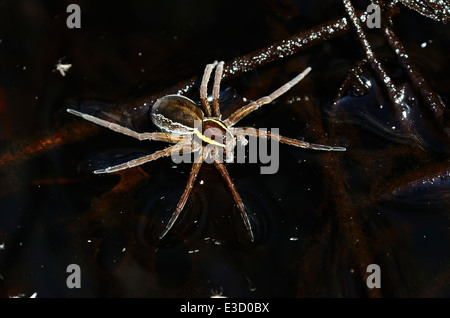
[0, 1, 450, 297]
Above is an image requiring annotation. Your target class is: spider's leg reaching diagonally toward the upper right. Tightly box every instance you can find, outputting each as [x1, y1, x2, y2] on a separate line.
[224, 67, 311, 127]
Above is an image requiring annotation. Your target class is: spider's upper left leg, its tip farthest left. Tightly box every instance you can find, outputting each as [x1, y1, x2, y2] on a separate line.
[67, 108, 186, 143]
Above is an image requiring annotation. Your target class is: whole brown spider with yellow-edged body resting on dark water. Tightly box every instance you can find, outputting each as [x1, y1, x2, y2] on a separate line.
[67, 61, 346, 242]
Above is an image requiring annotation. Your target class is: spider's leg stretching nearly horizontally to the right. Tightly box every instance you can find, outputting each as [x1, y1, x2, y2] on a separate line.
[230, 127, 346, 151]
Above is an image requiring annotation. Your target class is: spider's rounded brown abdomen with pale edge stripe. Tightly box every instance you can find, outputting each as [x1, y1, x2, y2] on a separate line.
[151, 95, 203, 134]
